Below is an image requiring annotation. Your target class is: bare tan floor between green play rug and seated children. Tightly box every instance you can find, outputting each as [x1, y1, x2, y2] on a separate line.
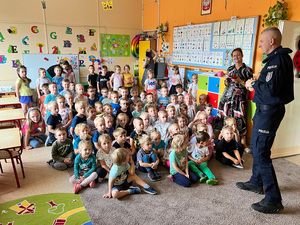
[0, 144, 300, 203]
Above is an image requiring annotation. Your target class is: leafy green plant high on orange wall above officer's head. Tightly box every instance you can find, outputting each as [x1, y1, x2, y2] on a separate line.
[262, 0, 288, 27]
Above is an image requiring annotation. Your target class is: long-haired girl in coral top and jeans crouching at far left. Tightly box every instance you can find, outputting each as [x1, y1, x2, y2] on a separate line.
[22, 108, 47, 150]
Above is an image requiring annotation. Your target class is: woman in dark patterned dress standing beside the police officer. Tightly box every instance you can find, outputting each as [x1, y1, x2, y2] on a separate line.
[216, 48, 253, 152]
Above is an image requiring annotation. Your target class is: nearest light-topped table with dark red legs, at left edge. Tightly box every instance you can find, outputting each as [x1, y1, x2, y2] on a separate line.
[0, 128, 25, 187]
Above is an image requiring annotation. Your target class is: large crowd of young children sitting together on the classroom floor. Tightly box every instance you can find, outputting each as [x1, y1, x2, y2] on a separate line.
[18, 63, 243, 198]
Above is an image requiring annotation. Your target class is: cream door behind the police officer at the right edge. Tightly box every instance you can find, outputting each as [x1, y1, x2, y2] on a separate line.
[271, 21, 300, 158]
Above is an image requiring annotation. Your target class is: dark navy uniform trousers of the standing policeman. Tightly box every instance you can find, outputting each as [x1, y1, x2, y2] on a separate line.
[250, 106, 285, 202]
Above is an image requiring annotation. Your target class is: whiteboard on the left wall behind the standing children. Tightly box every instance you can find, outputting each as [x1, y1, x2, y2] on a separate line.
[22, 54, 79, 89]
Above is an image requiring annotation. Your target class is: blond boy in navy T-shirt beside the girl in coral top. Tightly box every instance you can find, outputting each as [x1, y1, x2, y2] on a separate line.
[45, 101, 62, 146]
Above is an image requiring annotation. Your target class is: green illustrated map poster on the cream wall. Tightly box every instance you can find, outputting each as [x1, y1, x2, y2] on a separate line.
[101, 34, 130, 57]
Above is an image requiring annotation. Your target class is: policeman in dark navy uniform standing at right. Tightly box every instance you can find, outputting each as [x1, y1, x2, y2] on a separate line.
[236, 27, 294, 213]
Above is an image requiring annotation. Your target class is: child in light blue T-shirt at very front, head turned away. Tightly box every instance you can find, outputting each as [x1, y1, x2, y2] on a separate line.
[103, 148, 157, 198]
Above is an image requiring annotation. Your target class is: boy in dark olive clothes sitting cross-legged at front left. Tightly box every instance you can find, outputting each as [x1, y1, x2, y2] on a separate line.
[47, 127, 74, 170]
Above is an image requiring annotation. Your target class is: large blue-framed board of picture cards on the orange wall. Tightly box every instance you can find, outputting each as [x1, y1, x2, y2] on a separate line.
[173, 16, 258, 69]
